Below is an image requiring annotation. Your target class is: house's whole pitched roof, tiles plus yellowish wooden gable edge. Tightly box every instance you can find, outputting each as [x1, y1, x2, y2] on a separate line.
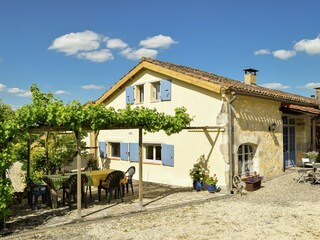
[96, 58, 320, 108]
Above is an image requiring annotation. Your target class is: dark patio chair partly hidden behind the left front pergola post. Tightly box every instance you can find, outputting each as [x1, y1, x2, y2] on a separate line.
[62, 174, 88, 210]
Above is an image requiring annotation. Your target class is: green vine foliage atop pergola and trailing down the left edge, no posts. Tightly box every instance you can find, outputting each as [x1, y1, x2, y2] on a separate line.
[0, 84, 192, 220]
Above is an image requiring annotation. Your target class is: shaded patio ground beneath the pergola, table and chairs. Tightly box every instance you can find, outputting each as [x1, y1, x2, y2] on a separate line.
[2, 181, 193, 235]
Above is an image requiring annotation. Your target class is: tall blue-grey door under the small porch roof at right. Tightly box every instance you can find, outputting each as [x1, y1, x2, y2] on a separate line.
[283, 117, 296, 168]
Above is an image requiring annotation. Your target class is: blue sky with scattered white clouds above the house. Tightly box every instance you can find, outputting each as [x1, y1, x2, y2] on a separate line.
[0, 0, 320, 109]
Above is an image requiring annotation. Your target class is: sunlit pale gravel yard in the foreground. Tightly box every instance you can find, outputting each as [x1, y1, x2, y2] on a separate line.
[3, 171, 320, 240]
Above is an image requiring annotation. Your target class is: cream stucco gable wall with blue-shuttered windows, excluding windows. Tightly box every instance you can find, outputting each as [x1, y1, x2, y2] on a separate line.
[93, 70, 227, 186]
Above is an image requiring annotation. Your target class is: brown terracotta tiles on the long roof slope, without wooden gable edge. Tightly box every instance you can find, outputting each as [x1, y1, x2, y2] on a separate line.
[141, 58, 320, 107]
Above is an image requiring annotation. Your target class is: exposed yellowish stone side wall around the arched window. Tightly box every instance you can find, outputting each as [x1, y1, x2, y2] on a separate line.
[233, 95, 283, 178]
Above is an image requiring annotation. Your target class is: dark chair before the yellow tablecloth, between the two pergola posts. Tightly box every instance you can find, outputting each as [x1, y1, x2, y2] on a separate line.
[98, 170, 124, 203]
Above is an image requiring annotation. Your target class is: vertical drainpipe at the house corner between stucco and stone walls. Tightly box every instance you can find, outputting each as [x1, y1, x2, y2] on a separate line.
[222, 92, 236, 193]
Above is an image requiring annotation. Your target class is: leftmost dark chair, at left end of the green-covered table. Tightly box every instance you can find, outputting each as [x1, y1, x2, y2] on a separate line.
[27, 178, 46, 210]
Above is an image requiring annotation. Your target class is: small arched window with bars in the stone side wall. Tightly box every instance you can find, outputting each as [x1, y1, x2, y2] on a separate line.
[238, 144, 253, 175]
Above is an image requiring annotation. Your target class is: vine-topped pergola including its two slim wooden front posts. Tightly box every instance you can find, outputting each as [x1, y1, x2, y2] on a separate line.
[13, 85, 192, 218]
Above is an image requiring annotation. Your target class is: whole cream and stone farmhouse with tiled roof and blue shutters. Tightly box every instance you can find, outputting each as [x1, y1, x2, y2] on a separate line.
[88, 58, 320, 190]
